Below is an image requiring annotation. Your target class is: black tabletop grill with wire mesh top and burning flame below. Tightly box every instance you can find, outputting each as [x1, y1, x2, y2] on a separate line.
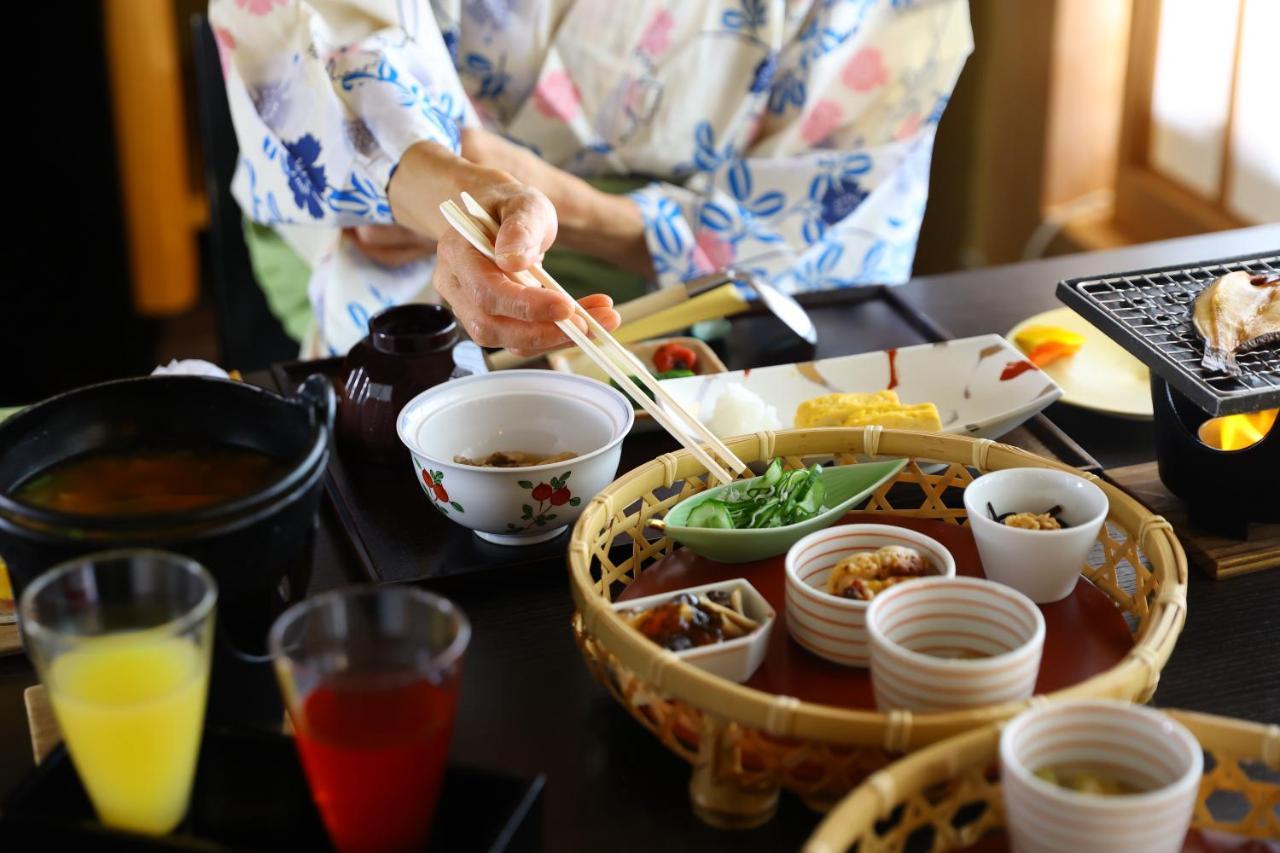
[1057, 250, 1280, 539]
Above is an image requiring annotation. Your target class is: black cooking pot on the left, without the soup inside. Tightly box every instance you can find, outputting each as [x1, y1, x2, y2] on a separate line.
[0, 377, 334, 660]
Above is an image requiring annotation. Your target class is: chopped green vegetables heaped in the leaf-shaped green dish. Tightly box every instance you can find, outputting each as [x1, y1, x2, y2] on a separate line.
[686, 459, 827, 530]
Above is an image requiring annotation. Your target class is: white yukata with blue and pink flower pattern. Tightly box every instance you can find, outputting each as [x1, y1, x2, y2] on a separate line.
[210, 0, 972, 351]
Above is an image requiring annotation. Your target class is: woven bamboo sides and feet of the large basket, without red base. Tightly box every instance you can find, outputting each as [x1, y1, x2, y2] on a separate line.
[568, 427, 1187, 827]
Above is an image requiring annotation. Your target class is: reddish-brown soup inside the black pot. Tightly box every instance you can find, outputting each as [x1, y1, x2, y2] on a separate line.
[14, 446, 287, 516]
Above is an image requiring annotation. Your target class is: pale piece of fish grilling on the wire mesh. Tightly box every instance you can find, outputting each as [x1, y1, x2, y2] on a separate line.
[1192, 272, 1280, 377]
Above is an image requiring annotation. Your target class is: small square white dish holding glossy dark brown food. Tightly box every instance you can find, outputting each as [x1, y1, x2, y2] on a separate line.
[613, 578, 774, 683]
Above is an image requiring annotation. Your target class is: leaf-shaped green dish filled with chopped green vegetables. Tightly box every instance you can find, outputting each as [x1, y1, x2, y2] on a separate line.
[650, 459, 906, 562]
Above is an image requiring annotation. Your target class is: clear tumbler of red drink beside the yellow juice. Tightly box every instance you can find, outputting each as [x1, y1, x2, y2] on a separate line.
[270, 587, 471, 853]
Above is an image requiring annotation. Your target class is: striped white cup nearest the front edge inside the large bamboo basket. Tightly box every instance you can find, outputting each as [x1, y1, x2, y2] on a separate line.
[867, 578, 1044, 712]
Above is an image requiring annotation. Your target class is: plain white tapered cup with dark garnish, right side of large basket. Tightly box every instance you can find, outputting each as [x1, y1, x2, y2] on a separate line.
[964, 467, 1110, 605]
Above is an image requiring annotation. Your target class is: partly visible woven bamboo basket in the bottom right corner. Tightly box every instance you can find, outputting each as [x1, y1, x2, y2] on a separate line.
[804, 711, 1280, 853]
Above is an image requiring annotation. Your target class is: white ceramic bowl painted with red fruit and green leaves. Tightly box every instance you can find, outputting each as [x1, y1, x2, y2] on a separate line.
[396, 370, 634, 544]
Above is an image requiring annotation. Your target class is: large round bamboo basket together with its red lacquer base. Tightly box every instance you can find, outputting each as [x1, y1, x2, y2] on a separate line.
[568, 428, 1187, 826]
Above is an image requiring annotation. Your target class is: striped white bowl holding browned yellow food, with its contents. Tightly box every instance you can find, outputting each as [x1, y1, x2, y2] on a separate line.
[785, 524, 956, 666]
